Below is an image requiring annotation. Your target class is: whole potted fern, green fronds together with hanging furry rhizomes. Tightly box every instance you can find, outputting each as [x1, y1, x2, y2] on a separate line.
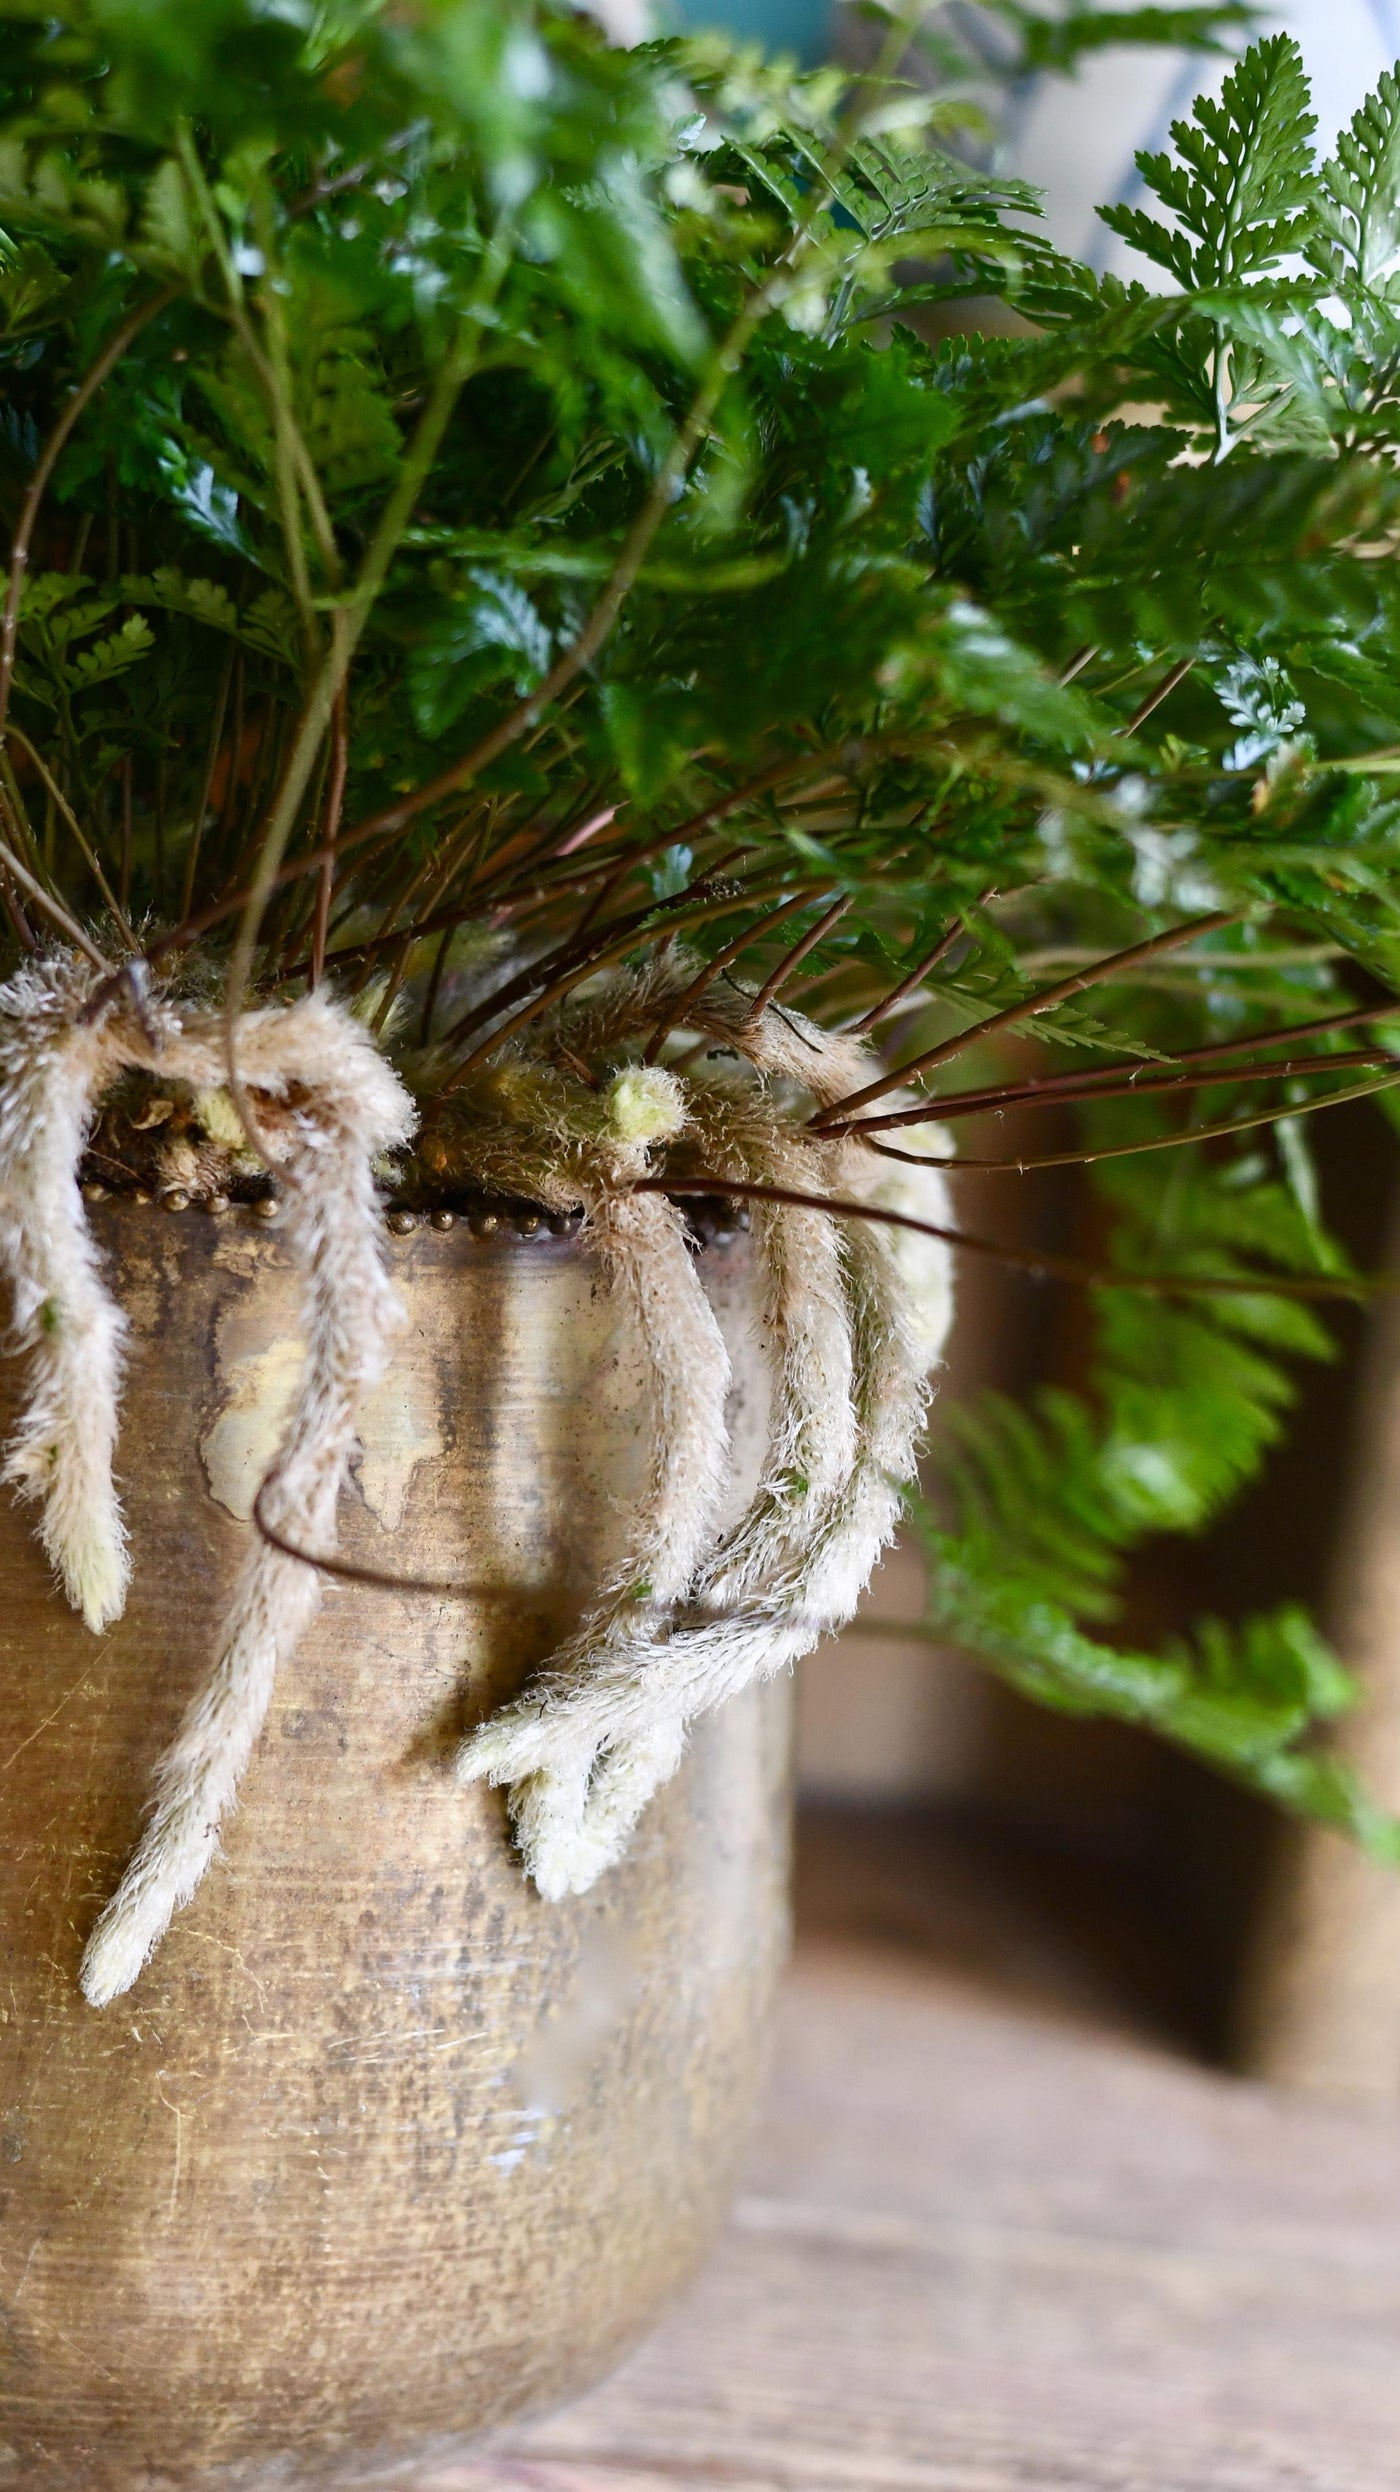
[0, 0, 1400, 1999]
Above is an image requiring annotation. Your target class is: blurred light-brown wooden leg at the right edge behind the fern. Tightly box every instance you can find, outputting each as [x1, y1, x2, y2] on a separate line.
[1238, 1209, 1400, 2103]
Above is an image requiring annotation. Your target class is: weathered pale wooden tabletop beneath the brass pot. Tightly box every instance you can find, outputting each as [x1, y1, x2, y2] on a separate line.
[416, 1814, 1400, 2492]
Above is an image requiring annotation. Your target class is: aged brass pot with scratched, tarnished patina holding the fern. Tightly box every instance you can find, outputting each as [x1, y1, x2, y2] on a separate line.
[0, 1204, 787, 2492]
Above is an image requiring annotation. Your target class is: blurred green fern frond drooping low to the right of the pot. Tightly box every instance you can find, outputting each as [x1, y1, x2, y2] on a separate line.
[919, 1164, 1375, 1857]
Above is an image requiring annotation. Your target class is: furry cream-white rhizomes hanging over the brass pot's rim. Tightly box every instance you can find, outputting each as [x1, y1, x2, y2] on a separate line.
[0, 952, 952, 2006]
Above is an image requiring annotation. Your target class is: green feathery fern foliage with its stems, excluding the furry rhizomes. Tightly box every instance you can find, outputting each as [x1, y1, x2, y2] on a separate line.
[0, 0, 1400, 1854]
